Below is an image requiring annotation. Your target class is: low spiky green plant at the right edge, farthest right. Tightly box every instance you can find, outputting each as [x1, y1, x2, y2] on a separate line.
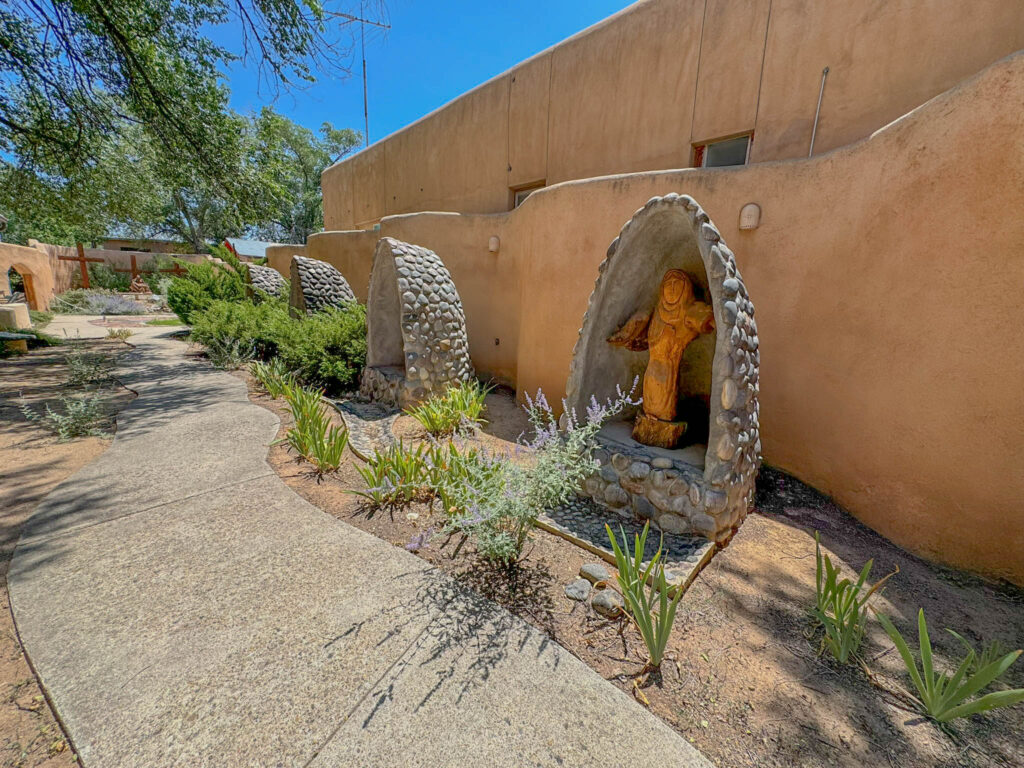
[874, 608, 1024, 723]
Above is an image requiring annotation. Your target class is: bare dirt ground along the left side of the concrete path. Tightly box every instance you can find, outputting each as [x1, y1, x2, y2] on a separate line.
[0, 340, 132, 768]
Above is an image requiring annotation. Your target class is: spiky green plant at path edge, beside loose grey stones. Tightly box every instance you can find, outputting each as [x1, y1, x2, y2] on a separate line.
[604, 522, 683, 670]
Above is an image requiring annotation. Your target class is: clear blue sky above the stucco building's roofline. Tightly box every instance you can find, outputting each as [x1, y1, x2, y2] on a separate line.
[216, 0, 631, 141]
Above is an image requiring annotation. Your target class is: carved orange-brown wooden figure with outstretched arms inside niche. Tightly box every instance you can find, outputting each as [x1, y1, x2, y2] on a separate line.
[608, 269, 715, 449]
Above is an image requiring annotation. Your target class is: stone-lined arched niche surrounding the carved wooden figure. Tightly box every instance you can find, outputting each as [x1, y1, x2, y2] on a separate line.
[566, 194, 761, 544]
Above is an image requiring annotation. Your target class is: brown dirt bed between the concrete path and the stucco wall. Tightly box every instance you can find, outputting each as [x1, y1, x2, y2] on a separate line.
[251, 380, 1024, 768]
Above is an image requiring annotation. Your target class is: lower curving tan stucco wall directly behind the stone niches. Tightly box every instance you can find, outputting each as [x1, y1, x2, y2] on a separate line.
[311, 53, 1024, 584]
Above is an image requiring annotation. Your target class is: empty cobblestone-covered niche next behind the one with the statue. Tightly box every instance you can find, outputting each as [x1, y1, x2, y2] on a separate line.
[360, 238, 474, 408]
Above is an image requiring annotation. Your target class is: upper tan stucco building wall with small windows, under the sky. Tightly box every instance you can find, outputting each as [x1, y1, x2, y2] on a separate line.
[323, 0, 1024, 229]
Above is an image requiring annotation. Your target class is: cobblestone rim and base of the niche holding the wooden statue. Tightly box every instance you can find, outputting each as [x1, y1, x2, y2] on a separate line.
[566, 194, 761, 544]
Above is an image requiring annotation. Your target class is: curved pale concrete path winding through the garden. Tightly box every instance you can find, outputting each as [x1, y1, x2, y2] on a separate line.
[8, 321, 710, 768]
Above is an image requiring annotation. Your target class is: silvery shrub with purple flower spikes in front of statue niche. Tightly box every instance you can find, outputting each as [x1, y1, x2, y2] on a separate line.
[446, 383, 636, 564]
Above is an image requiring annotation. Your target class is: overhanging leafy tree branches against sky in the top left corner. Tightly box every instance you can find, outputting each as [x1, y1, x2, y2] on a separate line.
[0, 0, 376, 177]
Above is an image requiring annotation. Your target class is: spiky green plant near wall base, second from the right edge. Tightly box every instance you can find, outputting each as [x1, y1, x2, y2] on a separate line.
[811, 531, 899, 664]
